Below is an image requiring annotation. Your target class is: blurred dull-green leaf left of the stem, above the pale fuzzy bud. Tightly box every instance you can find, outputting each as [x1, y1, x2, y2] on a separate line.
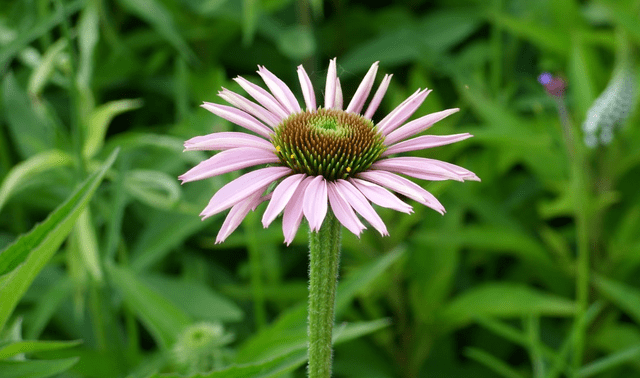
[142, 275, 244, 322]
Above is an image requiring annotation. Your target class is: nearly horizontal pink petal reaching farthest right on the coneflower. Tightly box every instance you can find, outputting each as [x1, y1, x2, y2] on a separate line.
[371, 156, 464, 181]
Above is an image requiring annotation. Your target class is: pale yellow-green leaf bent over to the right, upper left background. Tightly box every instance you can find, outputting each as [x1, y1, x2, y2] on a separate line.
[82, 100, 142, 158]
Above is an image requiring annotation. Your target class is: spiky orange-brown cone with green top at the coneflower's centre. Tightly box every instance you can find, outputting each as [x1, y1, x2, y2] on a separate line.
[272, 109, 386, 181]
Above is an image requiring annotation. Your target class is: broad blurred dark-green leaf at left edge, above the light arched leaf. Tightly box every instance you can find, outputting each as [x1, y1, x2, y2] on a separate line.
[2, 72, 53, 157]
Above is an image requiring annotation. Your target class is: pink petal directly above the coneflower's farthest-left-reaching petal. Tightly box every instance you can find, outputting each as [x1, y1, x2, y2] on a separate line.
[184, 131, 276, 152]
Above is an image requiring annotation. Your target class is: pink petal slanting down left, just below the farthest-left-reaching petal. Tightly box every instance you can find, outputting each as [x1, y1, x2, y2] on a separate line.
[200, 167, 292, 219]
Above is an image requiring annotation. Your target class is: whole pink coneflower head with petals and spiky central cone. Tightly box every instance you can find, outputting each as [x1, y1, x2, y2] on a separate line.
[180, 59, 479, 244]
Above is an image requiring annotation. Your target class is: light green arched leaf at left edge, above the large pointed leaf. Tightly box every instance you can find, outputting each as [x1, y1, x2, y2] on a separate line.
[0, 150, 73, 210]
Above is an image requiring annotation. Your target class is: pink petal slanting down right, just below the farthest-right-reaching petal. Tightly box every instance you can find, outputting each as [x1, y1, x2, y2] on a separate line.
[358, 170, 445, 214]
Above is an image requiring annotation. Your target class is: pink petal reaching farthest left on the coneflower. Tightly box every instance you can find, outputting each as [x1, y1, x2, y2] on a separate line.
[178, 147, 280, 184]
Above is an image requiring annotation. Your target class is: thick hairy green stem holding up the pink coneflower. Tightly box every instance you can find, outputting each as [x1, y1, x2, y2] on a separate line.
[308, 211, 341, 378]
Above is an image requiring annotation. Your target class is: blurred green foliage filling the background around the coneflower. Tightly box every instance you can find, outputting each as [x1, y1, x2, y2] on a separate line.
[0, 0, 640, 378]
